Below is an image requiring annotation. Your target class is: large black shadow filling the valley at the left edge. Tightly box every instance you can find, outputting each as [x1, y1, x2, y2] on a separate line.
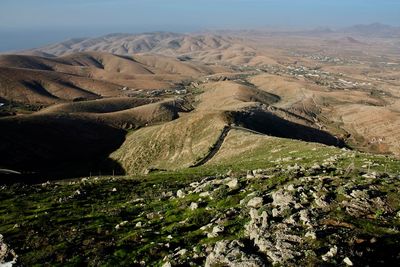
[0, 115, 125, 183]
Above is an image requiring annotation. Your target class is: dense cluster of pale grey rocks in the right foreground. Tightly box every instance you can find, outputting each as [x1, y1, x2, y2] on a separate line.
[207, 157, 400, 266]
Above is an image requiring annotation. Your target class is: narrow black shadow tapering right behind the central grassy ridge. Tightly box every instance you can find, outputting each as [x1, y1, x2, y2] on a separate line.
[231, 109, 347, 147]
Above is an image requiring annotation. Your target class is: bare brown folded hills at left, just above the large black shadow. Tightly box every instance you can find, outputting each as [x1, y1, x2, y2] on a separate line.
[0, 52, 227, 105]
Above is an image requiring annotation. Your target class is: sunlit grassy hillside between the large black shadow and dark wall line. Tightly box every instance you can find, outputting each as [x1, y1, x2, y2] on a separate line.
[111, 113, 225, 173]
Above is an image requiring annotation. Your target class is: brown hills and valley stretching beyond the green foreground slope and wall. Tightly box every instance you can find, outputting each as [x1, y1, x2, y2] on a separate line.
[0, 25, 400, 181]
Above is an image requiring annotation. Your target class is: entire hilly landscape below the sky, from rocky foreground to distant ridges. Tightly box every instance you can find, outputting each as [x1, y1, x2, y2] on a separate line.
[0, 29, 400, 267]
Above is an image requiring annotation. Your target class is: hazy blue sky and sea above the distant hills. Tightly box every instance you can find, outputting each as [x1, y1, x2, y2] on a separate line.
[0, 0, 400, 51]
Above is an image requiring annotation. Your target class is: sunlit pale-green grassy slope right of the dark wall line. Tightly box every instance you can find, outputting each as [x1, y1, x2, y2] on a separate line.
[207, 130, 400, 174]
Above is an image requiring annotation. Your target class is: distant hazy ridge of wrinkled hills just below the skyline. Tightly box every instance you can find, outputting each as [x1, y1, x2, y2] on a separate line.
[17, 32, 273, 64]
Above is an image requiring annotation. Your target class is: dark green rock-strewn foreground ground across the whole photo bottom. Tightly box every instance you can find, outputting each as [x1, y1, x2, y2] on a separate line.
[0, 151, 400, 267]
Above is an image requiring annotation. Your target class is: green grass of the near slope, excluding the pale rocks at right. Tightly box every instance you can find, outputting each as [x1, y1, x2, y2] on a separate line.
[0, 133, 400, 266]
